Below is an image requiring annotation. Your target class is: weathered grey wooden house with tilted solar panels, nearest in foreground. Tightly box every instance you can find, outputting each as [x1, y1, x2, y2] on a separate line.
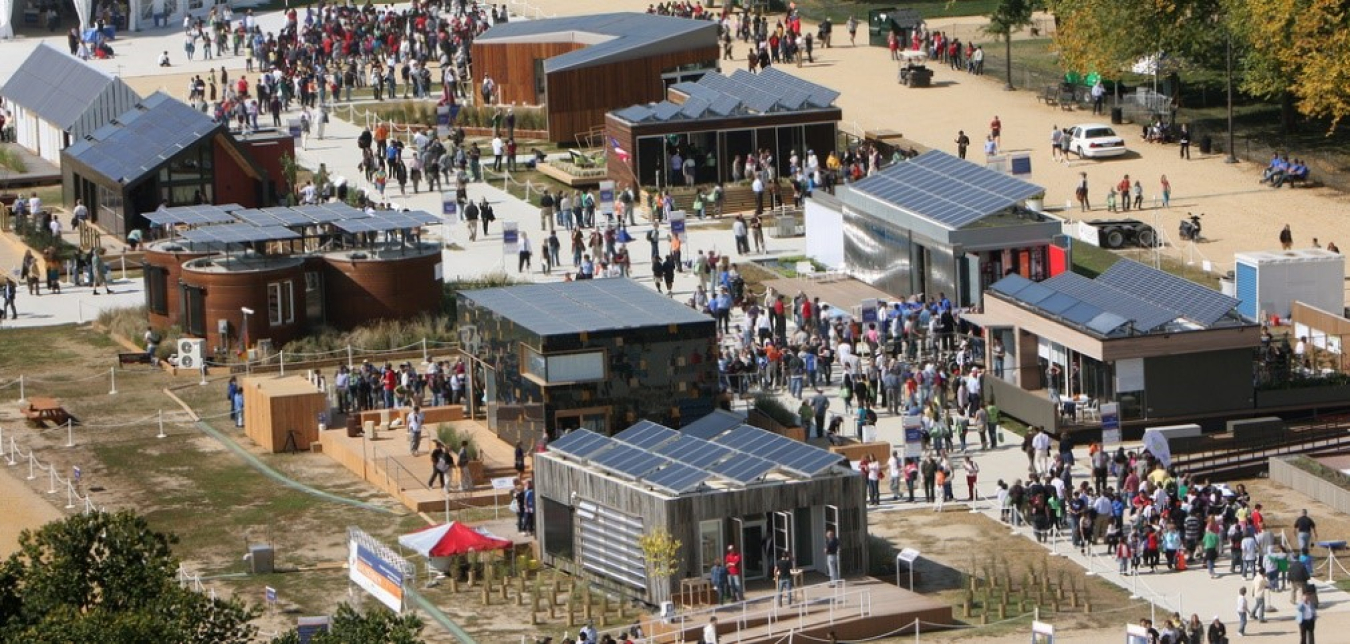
[533, 419, 867, 605]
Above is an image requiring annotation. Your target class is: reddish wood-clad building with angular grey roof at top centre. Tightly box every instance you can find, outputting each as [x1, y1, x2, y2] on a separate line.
[473, 12, 718, 143]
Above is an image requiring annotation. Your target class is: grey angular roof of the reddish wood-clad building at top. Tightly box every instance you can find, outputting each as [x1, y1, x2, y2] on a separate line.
[474, 12, 720, 74]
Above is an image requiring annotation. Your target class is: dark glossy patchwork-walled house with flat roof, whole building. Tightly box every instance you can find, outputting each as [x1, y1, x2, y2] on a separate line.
[455, 278, 718, 444]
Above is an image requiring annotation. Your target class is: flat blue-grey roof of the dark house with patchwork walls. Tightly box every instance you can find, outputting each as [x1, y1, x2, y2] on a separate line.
[459, 277, 713, 336]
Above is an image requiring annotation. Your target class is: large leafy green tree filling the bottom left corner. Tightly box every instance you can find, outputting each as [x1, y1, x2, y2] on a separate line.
[0, 512, 258, 644]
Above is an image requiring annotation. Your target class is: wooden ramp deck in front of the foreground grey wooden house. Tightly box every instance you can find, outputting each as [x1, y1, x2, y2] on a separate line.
[645, 576, 954, 644]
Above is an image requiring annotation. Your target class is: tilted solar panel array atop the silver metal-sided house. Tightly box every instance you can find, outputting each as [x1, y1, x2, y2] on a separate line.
[852, 150, 1045, 231]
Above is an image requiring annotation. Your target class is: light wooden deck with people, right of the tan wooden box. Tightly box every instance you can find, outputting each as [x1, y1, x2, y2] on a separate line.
[319, 420, 529, 513]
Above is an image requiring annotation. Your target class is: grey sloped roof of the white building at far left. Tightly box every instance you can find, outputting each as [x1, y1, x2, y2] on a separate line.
[0, 43, 139, 130]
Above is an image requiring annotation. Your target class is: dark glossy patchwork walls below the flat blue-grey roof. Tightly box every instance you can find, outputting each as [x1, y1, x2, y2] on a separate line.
[458, 297, 717, 444]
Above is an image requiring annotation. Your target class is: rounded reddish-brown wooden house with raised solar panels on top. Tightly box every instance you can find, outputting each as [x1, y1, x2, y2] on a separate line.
[142, 201, 441, 360]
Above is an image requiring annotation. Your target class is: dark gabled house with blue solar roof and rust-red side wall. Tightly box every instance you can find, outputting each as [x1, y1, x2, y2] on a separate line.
[61, 92, 296, 236]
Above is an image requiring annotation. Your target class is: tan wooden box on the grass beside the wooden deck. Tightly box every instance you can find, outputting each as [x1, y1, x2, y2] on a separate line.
[242, 375, 328, 452]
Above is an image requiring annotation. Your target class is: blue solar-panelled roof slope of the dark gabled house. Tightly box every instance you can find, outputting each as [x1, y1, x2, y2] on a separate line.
[63, 92, 221, 184]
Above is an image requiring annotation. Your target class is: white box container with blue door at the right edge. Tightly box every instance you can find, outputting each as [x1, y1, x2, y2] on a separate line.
[1234, 248, 1346, 320]
